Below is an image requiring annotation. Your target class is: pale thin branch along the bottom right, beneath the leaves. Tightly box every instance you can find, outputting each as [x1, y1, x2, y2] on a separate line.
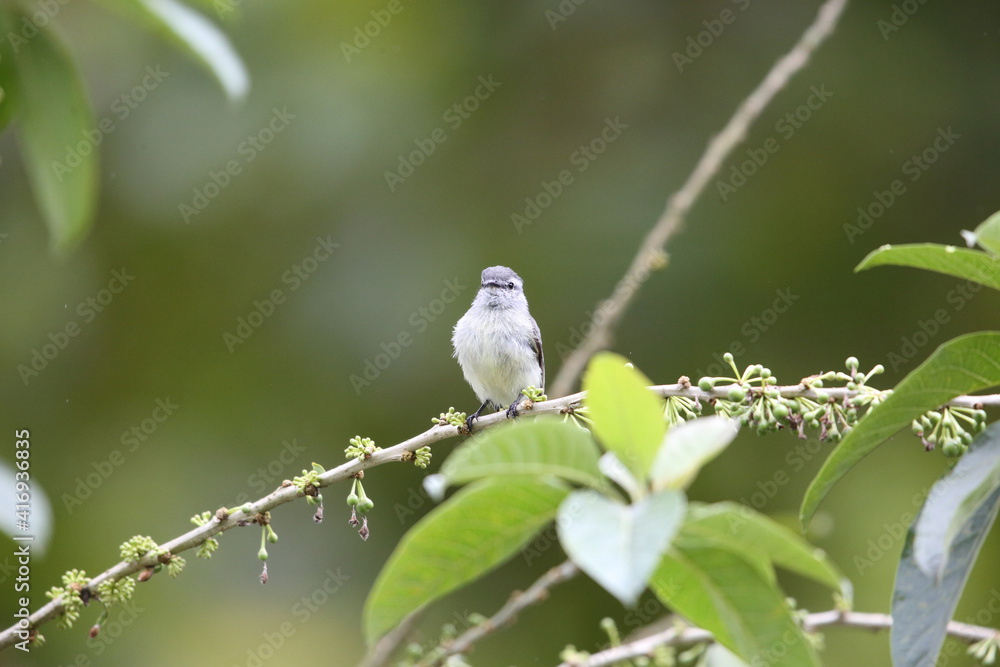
[559, 609, 1000, 667]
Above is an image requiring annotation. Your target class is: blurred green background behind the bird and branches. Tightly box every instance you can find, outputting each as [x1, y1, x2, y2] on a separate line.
[0, 0, 1000, 666]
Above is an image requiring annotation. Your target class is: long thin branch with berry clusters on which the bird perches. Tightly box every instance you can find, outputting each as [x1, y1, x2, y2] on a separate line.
[0, 382, 1000, 650]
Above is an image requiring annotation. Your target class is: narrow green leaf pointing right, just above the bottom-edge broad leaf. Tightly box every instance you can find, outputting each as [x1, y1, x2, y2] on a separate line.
[678, 502, 851, 601]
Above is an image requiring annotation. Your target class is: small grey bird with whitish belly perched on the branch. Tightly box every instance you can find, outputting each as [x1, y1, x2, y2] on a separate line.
[451, 266, 545, 430]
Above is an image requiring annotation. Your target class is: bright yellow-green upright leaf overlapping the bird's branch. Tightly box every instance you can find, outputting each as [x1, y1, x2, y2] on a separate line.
[583, 352, 667, 480]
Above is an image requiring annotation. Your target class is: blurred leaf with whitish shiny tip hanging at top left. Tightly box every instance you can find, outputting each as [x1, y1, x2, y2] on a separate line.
[94, 0, 250, 100]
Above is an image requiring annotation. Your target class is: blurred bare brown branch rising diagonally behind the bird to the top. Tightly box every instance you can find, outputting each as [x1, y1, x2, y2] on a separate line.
[551, 0, 847, 396]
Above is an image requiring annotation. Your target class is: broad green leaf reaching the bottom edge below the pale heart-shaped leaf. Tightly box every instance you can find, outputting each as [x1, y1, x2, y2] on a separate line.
[650, 544, 819, 667]
